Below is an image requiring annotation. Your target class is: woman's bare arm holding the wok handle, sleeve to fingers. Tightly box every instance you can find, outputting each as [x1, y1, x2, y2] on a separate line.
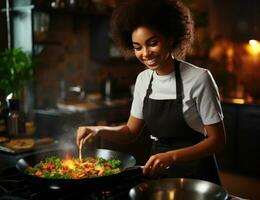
[144, 121, 226, 175]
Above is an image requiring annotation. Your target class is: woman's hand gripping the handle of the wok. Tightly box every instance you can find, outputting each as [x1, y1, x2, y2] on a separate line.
[143, 152, 173, 177]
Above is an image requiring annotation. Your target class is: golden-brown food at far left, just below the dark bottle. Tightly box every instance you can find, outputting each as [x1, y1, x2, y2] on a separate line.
[5, 138, 35, 149]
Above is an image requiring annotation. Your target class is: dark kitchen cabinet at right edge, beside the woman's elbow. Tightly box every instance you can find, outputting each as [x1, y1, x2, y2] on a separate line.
[217, 103, 260, 177]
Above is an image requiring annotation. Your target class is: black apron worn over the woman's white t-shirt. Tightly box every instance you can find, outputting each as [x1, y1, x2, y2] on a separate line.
[143, 59, 221, 185]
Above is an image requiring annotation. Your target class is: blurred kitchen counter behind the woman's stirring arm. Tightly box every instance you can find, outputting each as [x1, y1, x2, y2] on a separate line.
[34, 99, 131, 137]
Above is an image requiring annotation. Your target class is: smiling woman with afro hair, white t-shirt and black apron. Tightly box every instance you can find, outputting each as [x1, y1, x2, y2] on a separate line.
[77, 0, 225, 184]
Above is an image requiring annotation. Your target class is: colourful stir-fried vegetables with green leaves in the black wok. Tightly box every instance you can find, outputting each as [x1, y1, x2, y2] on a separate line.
[25, 156, 121, 179]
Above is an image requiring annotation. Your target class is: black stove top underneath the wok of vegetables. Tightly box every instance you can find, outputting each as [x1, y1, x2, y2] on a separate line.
[0, 167, 142, 200]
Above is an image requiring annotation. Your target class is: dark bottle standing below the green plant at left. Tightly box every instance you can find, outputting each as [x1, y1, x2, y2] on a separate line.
[7, 99, 25, 137]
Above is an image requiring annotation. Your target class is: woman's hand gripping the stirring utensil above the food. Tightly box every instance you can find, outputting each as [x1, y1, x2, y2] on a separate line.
[76, 126, 101, 146]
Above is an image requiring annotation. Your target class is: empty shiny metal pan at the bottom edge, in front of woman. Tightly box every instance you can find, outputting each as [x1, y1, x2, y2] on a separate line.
[129, 178, 228, 200]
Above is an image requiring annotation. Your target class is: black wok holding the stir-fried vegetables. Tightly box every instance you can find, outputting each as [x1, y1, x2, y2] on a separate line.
[16, 149, 142, 189]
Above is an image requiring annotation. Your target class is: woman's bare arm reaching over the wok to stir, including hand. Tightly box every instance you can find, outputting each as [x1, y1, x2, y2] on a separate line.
[76, 116, 143, 146]
